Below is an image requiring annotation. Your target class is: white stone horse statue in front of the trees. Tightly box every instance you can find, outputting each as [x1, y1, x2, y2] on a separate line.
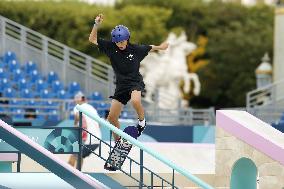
[140, 32, 200, 109]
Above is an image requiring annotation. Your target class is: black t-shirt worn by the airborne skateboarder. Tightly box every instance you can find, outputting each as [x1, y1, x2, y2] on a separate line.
[98, 39, 152, 85]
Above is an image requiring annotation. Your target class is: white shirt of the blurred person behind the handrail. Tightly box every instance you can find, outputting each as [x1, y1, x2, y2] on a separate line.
[73, 103, 102, 144]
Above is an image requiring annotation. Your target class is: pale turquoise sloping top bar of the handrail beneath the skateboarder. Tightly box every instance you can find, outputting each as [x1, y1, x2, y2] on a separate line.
[76, 105, 213, 189]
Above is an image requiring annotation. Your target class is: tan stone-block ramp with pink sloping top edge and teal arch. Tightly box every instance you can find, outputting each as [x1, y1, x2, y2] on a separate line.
[215, 110, 284, 189]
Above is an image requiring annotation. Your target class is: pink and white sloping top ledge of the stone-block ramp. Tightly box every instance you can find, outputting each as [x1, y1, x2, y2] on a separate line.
[216, 110, 284, 165]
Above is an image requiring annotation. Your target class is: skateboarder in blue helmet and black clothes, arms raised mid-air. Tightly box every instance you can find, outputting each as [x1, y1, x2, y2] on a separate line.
[89, 14, 168, 140]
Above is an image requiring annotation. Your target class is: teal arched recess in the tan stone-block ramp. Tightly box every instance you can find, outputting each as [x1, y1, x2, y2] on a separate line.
[230, 158, 257, 189]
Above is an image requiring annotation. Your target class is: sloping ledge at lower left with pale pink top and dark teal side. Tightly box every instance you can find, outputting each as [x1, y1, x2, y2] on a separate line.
[0, 120, 109, 189]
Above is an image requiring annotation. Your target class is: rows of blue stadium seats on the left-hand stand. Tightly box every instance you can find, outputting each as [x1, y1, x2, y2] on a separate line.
[0, 51, 109, 121]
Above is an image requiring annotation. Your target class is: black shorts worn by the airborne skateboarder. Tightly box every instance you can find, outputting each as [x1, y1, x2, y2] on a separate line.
[110, 83, 145, 105]
